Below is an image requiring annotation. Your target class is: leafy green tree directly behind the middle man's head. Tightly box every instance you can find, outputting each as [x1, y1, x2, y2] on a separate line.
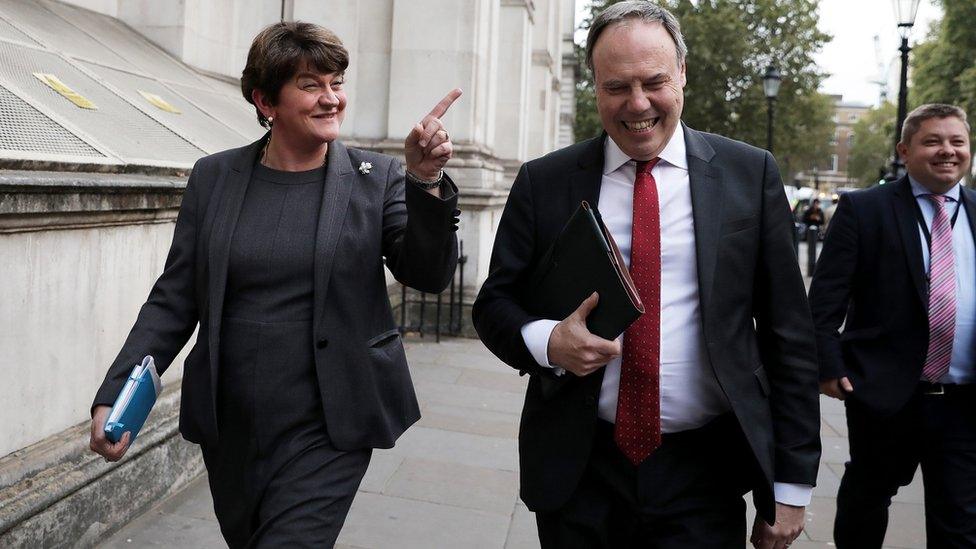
[576, 0, 834, 181]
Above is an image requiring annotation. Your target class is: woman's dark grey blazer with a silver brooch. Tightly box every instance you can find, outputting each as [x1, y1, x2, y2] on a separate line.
[94, 136, 458, 450]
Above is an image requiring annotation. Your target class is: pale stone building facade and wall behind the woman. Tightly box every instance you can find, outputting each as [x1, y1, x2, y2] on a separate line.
[0, 0, 576, 547]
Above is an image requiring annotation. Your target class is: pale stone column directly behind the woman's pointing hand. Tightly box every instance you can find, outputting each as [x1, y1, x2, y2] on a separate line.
[388, 0, 512, 296]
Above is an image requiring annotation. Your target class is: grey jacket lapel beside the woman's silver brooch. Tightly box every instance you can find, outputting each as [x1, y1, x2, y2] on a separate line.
[314, 141, 355, 323]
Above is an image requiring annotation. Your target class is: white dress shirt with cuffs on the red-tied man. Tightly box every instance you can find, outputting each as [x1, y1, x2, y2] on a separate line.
[521, 126, 813, 505]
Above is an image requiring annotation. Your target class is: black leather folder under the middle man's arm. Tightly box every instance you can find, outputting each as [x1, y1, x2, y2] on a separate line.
[526, 201, 644, 339]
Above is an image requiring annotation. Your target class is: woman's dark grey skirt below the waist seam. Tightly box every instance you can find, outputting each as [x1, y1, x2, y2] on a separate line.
[203, 317, 372, 549]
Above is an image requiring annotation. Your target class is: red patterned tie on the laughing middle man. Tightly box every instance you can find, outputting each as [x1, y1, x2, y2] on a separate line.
[613, 158, 661, 465]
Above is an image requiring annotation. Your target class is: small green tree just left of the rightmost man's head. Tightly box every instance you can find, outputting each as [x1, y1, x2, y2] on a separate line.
[847, 103, 896, 187]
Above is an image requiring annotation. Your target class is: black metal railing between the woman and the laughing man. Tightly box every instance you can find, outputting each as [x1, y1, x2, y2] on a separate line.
[395, 240, 468, 343]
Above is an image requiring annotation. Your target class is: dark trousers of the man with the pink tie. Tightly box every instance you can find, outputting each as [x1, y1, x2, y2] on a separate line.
[834, 385, 976, 549]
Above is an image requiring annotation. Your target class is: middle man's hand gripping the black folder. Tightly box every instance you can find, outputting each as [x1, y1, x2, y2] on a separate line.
[548, 292, 622, 376]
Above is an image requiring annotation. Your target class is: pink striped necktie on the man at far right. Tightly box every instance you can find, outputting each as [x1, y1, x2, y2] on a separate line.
[922, 194, 956, 383]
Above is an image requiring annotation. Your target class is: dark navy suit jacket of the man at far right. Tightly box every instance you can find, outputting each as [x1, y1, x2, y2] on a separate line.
[810, 176, 976, 415]
